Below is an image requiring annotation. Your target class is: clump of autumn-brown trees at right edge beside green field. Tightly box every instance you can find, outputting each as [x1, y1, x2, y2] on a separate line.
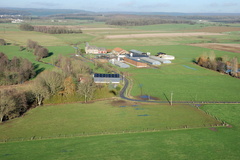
[196, 52, 240, 78]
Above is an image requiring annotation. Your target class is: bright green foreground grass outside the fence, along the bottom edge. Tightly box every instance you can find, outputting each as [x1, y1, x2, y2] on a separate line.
[0, 105, 240, 160]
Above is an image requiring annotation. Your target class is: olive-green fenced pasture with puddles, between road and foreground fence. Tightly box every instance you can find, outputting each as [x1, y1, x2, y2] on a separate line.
[0, 101, 220, 139]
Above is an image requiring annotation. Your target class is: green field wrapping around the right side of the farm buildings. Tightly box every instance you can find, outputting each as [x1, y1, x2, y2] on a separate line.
[115, 45, 240, 101]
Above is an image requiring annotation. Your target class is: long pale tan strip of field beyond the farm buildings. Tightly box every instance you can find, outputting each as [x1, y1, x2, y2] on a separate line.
[105, 32, 224, 39]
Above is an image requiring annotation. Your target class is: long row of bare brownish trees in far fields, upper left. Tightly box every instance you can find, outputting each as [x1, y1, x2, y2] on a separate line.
[19, 23, 82, 34]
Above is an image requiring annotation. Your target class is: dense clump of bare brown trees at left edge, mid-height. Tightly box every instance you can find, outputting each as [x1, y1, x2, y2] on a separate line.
[0, 52, 36, 85]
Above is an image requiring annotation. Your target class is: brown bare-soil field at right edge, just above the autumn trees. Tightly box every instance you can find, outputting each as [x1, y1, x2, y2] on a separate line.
[190, 43, 240, 53]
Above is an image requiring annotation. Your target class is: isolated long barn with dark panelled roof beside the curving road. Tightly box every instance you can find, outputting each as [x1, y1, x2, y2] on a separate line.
[93, 73, 121, 83]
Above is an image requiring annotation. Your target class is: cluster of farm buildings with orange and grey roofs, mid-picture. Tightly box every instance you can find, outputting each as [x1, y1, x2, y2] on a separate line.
[85, 43, 175, 68]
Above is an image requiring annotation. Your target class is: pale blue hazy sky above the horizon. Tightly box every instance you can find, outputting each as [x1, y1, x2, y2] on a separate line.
[0, 0, 240, 13]
